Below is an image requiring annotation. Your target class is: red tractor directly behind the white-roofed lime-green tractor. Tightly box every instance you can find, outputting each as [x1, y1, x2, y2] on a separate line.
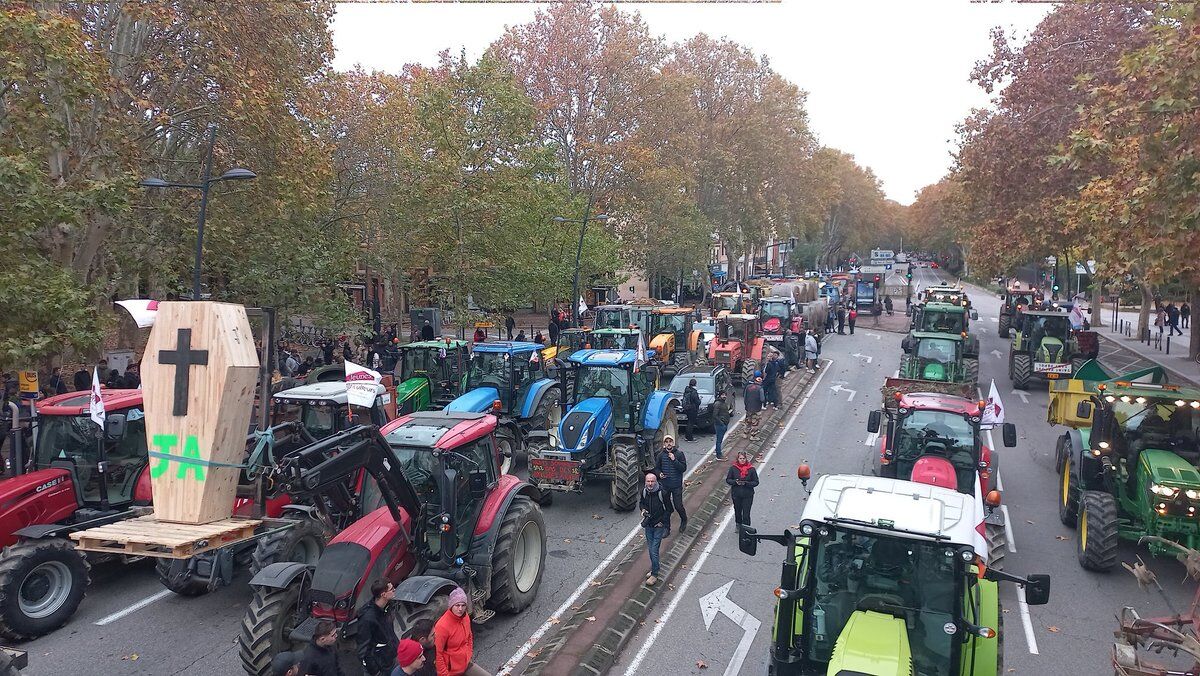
[866, 391, 1016, 570]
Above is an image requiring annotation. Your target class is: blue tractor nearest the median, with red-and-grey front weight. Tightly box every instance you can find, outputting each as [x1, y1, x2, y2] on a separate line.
[528, 349, 679, 512]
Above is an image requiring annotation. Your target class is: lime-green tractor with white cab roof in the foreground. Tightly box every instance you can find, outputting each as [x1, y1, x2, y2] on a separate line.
[738, 465, 1050, 676]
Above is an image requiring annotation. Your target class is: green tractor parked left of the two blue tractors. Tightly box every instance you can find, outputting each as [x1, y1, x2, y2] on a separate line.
[396, 339, 470, 415]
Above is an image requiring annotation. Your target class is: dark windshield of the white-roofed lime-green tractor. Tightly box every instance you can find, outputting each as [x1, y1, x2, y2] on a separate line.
[804, 528, 961, 676]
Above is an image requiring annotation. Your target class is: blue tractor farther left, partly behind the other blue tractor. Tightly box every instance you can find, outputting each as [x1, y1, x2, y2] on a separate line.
[445, 341, 563, 473]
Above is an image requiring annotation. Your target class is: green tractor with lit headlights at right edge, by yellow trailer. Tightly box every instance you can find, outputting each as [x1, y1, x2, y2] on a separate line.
[1048, 363, 1200, 570]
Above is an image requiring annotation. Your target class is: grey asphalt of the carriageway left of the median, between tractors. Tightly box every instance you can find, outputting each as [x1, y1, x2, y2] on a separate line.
[22, 393, 742, 676]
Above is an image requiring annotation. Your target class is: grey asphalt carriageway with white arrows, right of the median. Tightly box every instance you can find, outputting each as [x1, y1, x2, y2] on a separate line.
[613, 269, 1195, 676]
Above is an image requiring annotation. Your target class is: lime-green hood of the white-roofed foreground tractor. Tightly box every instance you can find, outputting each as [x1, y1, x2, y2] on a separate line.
[826, 610, 912, 676]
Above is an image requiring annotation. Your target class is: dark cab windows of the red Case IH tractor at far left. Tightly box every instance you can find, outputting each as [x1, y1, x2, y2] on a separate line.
[34, 408, 146, 503]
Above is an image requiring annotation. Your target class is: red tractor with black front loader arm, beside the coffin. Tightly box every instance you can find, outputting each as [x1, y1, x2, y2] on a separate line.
[238, 411, 546, 675]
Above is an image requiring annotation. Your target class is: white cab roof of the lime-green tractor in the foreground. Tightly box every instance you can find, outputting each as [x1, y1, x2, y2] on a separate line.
[803, 474, 988, 561]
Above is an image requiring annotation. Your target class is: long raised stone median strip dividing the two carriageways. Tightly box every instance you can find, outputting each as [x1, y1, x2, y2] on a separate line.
[522, 371, 814, 676]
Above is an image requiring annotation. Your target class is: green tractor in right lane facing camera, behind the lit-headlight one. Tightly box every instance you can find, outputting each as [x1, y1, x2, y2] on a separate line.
[1008, 309, 1099, 390]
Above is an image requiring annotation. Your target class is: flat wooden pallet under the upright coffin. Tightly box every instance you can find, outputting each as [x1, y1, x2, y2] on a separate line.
[71, 514, 263, 558]
